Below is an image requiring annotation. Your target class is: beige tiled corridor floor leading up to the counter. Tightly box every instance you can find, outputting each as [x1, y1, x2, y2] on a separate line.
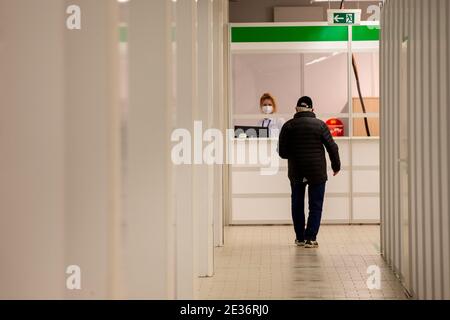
[198, 226, 406, 300]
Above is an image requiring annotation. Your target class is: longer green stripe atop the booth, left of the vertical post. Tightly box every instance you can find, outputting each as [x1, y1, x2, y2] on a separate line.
[231, 26, 348, 43]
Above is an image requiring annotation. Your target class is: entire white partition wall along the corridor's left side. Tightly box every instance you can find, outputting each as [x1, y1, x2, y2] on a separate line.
[0, 0, 228, 300]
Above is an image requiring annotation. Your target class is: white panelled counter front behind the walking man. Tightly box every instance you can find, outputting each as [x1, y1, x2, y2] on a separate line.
[230, 137, 380, 224]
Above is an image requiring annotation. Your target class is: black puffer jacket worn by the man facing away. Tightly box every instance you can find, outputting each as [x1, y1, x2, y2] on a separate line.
[278, 112, 341, 184]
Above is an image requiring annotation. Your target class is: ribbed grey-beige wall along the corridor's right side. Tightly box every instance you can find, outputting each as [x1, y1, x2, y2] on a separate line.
[380, 0, 450, 299]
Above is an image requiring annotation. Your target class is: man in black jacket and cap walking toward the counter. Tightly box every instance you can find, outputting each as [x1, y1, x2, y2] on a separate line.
[278, 97, 341, 248]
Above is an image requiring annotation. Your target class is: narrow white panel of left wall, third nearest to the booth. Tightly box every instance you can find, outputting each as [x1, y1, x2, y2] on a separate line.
[174, 0, 198, 299]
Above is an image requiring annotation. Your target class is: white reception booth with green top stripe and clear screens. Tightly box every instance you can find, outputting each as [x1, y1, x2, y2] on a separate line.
[229, 22, 380, 225]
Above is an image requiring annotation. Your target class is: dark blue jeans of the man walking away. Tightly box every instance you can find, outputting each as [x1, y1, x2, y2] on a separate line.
[291, 182, 326, 241]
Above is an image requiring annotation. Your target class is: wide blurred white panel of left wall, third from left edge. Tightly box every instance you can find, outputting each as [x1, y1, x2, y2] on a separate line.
[123, 0, 175, 299]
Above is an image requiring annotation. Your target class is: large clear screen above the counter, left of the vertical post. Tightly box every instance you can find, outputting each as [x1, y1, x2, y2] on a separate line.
[232, 52, 349, 136]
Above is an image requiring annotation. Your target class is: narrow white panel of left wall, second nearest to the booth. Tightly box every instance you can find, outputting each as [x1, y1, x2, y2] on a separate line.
[194, 0, 214, 276]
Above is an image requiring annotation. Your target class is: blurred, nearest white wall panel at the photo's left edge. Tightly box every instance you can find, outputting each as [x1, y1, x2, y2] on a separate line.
[0, 0, 65, 299]
